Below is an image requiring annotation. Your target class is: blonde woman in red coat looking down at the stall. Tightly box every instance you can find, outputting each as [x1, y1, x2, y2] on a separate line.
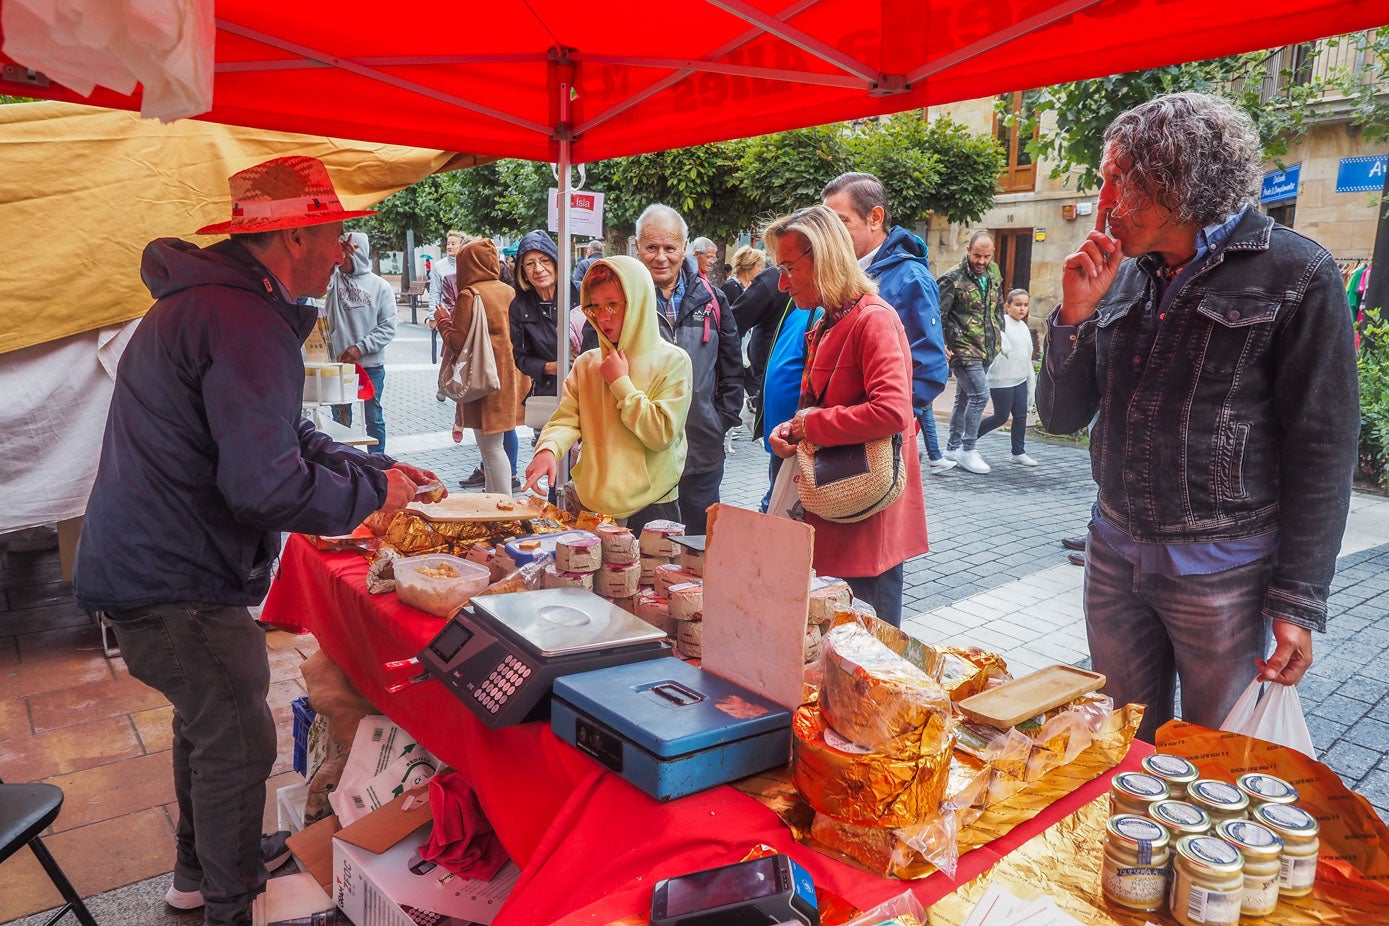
[765, 205, 928, 626]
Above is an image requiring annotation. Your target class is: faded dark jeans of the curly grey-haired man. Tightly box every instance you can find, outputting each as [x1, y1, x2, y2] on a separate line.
[1085, 528, 1271, 743]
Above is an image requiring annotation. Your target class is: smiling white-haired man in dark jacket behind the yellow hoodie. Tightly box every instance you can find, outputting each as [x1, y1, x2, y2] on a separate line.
[636, 204, 743, 534]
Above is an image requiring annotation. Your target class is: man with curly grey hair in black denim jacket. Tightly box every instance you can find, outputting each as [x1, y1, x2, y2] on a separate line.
[1038, 93, 1360, 741]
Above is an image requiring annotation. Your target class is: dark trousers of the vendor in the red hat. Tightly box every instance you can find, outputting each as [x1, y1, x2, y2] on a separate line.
[111, 601, 275, 926]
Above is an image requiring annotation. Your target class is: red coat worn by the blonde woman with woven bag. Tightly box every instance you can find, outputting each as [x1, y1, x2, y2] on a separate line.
[789, 296, 929, 578]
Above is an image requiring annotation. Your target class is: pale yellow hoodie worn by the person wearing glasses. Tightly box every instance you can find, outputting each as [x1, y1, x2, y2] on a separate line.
[535, 257, 692, 518]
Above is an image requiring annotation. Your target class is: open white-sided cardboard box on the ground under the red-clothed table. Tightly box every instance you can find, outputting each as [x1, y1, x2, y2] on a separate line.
[289, 787, 521, 926]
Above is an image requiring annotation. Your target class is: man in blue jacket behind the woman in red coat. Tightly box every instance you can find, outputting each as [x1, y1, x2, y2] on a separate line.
[820, 174, 956, 473]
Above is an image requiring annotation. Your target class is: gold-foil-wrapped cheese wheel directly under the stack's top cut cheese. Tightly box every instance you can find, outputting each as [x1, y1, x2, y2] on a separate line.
[790, 704, 950, 827]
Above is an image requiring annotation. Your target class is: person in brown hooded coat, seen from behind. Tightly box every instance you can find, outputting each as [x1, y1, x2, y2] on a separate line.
[435, 237, 531, 493]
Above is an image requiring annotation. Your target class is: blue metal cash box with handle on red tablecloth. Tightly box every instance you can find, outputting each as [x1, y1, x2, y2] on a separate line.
[550, 657, 790, 801]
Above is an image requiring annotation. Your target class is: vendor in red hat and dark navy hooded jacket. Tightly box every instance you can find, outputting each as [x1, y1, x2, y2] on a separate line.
[72, 157, 433, 926]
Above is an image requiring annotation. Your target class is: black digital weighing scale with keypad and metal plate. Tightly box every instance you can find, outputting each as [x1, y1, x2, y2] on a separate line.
[419, 589, 671, 729]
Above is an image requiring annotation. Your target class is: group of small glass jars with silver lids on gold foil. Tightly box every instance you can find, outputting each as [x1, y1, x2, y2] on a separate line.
[1100, 754, 1321, 926]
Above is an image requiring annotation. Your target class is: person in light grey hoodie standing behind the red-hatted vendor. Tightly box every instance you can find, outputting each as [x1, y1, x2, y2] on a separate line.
[324, 232, 396, 454]
